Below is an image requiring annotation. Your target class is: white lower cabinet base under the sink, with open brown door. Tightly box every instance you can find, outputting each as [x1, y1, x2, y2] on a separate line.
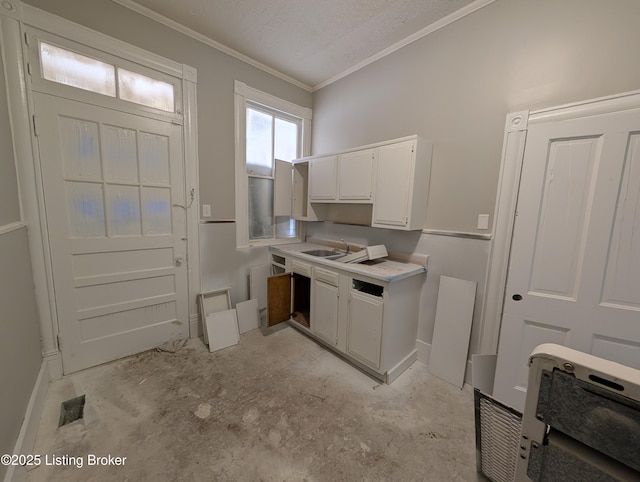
[266, 250, 424, 383]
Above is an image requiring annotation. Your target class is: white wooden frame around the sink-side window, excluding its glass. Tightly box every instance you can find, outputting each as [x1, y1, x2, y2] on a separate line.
[234, 80, 312, 248]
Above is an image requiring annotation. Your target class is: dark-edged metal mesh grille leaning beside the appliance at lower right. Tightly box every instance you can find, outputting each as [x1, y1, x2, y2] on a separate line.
[475, 389, 522, 482]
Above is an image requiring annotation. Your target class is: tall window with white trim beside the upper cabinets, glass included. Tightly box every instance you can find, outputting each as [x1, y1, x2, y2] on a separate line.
[235, 82, 311, 247]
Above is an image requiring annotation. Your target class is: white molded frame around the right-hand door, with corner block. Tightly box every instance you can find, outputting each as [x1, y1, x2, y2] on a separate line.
[479, 90, 640, 355]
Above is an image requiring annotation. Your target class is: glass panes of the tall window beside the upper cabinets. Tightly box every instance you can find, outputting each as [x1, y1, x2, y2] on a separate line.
[245, 106, 301, 241]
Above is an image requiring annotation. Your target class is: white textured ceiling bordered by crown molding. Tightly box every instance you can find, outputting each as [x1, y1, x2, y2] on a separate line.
[115, 0, 486, 87]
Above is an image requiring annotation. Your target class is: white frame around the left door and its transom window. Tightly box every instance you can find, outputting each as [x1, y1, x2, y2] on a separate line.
[0, 0, 201, 380]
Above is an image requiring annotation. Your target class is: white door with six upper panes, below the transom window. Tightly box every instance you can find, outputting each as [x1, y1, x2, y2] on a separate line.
[34, 93, 189, 373]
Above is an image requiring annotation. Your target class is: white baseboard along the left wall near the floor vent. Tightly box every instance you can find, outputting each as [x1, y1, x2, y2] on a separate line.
[4, 360, 49, 482]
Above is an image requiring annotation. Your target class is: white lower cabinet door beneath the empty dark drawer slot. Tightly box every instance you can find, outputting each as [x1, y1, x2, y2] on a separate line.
[347, 289, 384, 369]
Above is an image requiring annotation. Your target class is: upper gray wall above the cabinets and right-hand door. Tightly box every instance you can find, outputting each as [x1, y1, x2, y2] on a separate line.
[313, 0, 640, 233]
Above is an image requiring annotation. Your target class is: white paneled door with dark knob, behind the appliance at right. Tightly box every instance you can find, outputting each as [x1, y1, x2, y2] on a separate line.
[494, 106, 640, 410]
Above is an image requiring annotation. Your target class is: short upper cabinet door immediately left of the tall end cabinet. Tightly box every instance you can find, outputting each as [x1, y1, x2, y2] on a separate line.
[338, 149, 376, 202]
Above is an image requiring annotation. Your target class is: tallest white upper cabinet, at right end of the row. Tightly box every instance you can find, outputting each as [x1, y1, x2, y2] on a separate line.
[371, 137, 432, 230]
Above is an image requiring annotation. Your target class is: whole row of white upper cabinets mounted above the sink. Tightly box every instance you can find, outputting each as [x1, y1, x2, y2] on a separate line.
[293, 136, 432, 231]
